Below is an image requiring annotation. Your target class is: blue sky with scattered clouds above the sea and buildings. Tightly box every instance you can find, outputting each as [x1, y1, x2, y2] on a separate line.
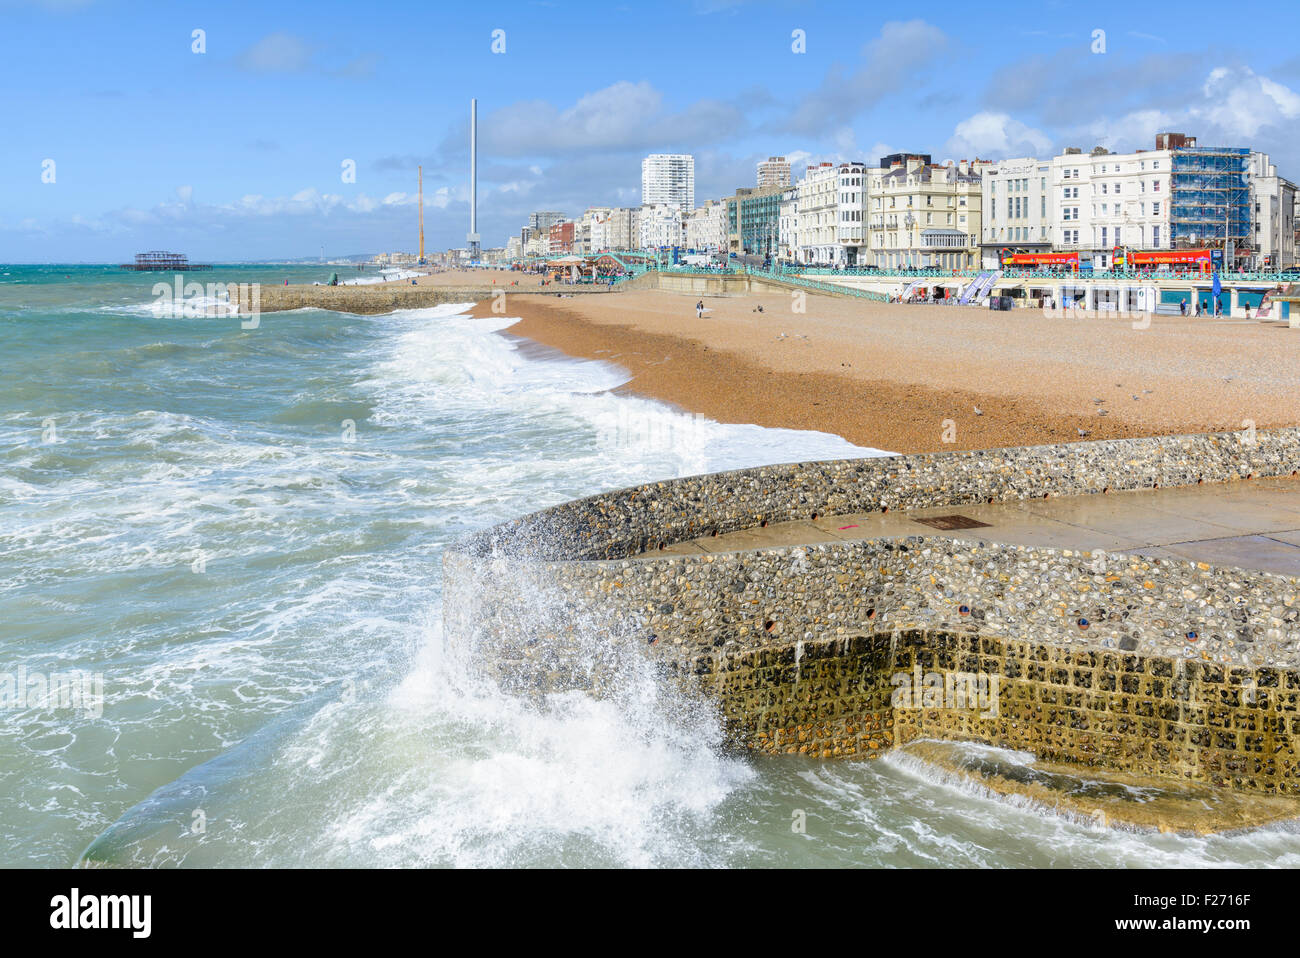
[0, 0, 1300, 263]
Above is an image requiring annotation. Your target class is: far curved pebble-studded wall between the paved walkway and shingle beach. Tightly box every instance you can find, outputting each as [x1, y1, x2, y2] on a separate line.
[460, 428, 1300, 560]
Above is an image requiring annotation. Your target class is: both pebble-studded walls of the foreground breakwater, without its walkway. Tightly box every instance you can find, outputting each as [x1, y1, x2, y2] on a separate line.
[445, 429, 1300, 796]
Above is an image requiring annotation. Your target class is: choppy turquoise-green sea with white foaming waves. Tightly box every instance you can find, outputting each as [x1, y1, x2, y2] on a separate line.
[0, 266, 1300, 867]
